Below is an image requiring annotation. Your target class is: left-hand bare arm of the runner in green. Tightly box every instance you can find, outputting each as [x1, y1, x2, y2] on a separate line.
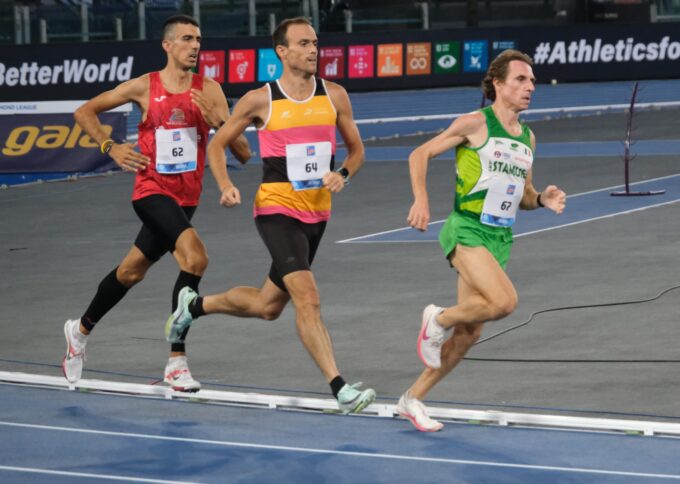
[407, 112, 486, 231]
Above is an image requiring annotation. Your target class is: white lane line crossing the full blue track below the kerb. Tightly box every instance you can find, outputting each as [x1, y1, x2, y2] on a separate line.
[0, 421, 680, 480]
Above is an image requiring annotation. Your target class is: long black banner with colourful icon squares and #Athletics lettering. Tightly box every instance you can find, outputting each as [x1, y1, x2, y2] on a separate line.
[0, 23, 680, 102]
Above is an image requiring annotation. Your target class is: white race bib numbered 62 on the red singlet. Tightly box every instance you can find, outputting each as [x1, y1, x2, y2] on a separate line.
[156, 127, 198, 175]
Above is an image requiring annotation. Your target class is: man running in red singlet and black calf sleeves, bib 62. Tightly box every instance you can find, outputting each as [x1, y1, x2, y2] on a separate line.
[62, 15, 250, 391]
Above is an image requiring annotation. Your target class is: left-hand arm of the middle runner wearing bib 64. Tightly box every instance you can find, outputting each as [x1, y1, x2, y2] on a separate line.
[208, 88, 269, 207]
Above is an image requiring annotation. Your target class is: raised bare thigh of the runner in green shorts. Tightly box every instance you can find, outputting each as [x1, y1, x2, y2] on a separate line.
[451, 245, 517, 301]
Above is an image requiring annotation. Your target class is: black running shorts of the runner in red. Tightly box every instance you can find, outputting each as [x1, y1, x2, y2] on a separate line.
[132, 195, 196, 262]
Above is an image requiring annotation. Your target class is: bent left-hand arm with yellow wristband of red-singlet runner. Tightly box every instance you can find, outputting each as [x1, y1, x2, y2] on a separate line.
[73, 75, 151, 172]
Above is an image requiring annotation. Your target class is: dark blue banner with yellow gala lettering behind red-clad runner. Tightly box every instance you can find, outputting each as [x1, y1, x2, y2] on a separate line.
[0, 112, 126, 173]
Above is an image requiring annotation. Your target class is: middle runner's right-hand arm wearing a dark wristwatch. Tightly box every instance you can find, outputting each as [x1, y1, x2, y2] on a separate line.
[323, 82, 365, 193]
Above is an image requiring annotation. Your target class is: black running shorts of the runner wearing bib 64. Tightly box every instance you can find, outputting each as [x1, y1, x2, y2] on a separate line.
[255, 214, 326, 291]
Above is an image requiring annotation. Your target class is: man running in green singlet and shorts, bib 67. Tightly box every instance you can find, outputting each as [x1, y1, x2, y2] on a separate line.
[397, 50, 566, 432]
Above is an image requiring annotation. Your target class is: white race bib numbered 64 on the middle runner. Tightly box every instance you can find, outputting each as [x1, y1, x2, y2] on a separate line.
[286, 141, 333, 191]
